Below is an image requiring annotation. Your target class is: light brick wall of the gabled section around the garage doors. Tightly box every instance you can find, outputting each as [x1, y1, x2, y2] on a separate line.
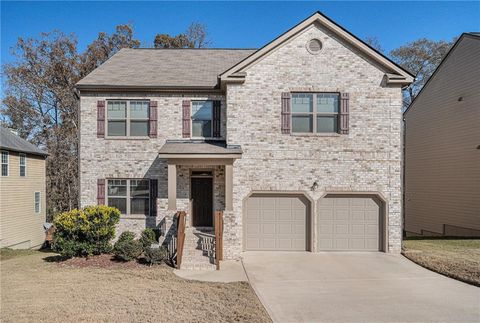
[224, 26, 402, 257]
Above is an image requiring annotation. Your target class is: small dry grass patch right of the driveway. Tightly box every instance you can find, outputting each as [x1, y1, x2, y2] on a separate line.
[403, 238, 480, 286]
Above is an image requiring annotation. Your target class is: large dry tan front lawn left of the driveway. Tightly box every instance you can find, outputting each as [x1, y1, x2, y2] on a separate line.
[0, 252, 271, 322]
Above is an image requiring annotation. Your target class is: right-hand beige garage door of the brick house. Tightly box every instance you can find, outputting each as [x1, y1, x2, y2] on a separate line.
[317, 196, 382, 251]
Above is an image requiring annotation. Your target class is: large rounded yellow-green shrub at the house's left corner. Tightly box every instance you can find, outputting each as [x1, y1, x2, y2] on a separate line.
[52, 205, 120, 258]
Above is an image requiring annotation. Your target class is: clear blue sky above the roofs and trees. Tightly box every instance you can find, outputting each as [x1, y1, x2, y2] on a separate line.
[1, 1, 480, 64]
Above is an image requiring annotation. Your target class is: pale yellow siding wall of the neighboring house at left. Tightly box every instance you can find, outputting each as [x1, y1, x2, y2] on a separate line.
[0, 151, 46, 248]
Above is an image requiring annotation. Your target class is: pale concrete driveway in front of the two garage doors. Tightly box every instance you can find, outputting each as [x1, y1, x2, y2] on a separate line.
[243, 252, 480, 322]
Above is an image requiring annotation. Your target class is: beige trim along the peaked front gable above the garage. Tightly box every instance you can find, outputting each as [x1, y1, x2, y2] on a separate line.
[220, 11, 414, 85]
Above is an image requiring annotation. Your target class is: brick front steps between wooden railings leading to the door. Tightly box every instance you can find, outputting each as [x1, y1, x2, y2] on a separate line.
[180, 228, 216, 270]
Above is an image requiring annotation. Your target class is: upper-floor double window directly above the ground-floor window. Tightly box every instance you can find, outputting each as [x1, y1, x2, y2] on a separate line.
[107, 100, 149, 137]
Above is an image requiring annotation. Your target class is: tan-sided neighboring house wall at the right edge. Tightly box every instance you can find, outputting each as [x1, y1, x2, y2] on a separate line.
[404, 33, 480, 236]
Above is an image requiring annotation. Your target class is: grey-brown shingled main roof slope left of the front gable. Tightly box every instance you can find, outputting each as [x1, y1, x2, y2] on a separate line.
[77, 48, 256, 89]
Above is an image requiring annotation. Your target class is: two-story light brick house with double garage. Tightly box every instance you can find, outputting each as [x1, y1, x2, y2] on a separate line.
[77, 13, 413, 266]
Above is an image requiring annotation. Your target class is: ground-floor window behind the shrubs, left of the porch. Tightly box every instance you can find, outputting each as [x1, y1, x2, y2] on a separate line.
[107, 179, 150, 215]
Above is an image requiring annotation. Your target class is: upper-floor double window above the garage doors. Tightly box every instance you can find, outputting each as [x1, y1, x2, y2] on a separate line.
[292, 93, 339, 133]
